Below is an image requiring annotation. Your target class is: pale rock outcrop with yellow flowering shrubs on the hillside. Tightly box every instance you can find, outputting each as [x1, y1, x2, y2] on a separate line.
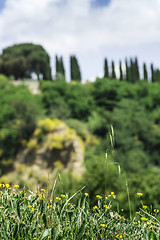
[1, 118, 85, 188]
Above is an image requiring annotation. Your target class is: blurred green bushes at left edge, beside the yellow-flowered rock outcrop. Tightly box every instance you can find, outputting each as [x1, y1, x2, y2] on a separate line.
[0, 81, 42, 168]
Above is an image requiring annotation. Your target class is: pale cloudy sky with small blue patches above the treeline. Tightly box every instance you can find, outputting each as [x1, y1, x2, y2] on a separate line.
[0, 0, 160, 81]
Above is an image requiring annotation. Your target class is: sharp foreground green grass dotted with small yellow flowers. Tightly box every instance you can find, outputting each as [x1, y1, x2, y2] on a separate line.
[0, 184, 160, 240]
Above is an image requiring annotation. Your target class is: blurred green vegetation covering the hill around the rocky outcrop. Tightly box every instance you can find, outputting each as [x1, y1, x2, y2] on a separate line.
[0, 42, 160, 219]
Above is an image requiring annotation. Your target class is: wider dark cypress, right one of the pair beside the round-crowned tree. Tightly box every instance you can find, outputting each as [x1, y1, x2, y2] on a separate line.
[70, 56, 81, 82]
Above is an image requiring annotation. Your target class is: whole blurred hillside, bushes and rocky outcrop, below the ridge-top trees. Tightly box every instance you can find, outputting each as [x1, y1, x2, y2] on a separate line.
[0, 74, 160, 215]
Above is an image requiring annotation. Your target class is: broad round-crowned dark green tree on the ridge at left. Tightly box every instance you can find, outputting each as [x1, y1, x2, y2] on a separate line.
[1, 43, 51, 79]
